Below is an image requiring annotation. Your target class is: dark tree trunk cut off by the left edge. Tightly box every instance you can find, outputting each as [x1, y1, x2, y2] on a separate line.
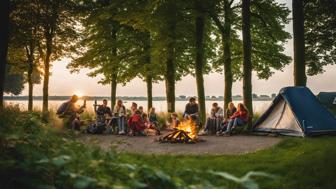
[0, 0, 10, 111]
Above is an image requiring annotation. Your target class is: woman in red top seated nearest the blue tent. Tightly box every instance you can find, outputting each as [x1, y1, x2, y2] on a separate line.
[223, 103, 249, 135]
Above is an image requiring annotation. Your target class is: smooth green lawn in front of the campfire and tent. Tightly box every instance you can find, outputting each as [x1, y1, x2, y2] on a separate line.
[119, 137, 336, 189]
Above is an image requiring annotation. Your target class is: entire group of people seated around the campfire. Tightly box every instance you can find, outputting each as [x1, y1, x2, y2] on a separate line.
[57, 95, 249, 136]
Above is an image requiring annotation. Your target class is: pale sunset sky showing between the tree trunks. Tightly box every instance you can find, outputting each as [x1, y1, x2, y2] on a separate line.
[22, 0, 336, 96]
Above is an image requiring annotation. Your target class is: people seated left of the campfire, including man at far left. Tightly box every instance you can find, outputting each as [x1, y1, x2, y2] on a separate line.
[57, 95, 160, 135]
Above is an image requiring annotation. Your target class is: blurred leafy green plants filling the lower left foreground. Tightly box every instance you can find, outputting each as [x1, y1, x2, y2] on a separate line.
[0, 107, 276, 189]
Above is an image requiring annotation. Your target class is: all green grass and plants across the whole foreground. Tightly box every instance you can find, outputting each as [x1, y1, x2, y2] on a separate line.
[0, 109, 336, 189]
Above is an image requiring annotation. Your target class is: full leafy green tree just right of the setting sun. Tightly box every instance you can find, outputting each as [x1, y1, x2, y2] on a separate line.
[68, 2, 147, 107]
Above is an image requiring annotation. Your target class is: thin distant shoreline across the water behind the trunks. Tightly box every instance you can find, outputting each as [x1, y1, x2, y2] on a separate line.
[4, 96, 273, 101]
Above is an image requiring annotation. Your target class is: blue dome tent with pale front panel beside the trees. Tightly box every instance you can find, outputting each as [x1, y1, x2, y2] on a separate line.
[253, 87, 336, 137]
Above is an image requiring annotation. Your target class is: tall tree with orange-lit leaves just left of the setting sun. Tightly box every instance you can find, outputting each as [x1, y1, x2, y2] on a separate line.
[35, 0, 78, 115]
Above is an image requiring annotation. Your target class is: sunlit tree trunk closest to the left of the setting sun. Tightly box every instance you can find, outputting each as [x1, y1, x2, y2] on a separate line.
[42, 33, 52, 115]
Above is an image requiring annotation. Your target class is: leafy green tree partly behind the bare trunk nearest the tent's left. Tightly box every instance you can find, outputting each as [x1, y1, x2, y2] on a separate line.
[207, 0, 290, 113]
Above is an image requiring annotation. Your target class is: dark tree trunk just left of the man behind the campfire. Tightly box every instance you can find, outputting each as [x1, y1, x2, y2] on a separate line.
[165, 4, 177, 112]
